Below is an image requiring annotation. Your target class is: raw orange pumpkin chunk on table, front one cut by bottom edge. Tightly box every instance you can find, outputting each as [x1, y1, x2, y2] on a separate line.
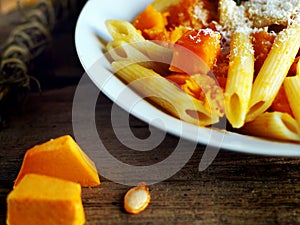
[7, 174, 85, 225]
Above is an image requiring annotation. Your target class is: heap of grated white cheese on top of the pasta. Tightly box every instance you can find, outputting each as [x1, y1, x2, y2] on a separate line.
[209, 0, 300, 51]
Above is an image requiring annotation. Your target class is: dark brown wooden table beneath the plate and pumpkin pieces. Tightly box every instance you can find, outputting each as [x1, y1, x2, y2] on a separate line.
[0, 7, 300, 225]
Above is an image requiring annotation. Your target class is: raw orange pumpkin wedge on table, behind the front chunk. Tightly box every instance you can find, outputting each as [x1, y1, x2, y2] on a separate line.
[14, 135, 100, 187]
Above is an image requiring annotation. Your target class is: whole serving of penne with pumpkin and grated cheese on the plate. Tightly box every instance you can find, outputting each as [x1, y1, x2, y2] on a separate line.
[106, 0, 300, 142]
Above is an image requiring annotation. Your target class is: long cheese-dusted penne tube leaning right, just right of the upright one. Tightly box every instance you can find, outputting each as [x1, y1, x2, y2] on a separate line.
[246, 23, 300, 121]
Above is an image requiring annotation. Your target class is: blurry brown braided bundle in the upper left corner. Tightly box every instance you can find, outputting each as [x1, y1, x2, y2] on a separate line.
[0, 0, 81, 127]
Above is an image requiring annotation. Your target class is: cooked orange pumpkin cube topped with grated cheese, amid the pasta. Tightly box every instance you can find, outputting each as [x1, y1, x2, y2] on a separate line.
[170, 28, 221, 74]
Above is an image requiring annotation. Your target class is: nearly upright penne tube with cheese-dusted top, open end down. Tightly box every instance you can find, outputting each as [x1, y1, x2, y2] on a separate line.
[225, 32, 254, 128]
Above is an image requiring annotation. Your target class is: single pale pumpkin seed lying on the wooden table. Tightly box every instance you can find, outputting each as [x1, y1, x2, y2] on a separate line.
[124, 185, 150, 214]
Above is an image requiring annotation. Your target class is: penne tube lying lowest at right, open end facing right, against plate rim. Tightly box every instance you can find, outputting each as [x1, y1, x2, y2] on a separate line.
[241, 112, 300, 142]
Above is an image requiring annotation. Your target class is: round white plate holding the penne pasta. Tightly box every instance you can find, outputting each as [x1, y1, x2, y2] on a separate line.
[75, 0, 300, 156]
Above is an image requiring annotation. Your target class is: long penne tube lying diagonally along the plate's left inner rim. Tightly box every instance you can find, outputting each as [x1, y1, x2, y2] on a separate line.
[112, 61, 219, 126]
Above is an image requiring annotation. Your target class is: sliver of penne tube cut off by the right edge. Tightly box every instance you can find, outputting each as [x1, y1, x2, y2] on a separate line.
[283, 76, 300, 125]
